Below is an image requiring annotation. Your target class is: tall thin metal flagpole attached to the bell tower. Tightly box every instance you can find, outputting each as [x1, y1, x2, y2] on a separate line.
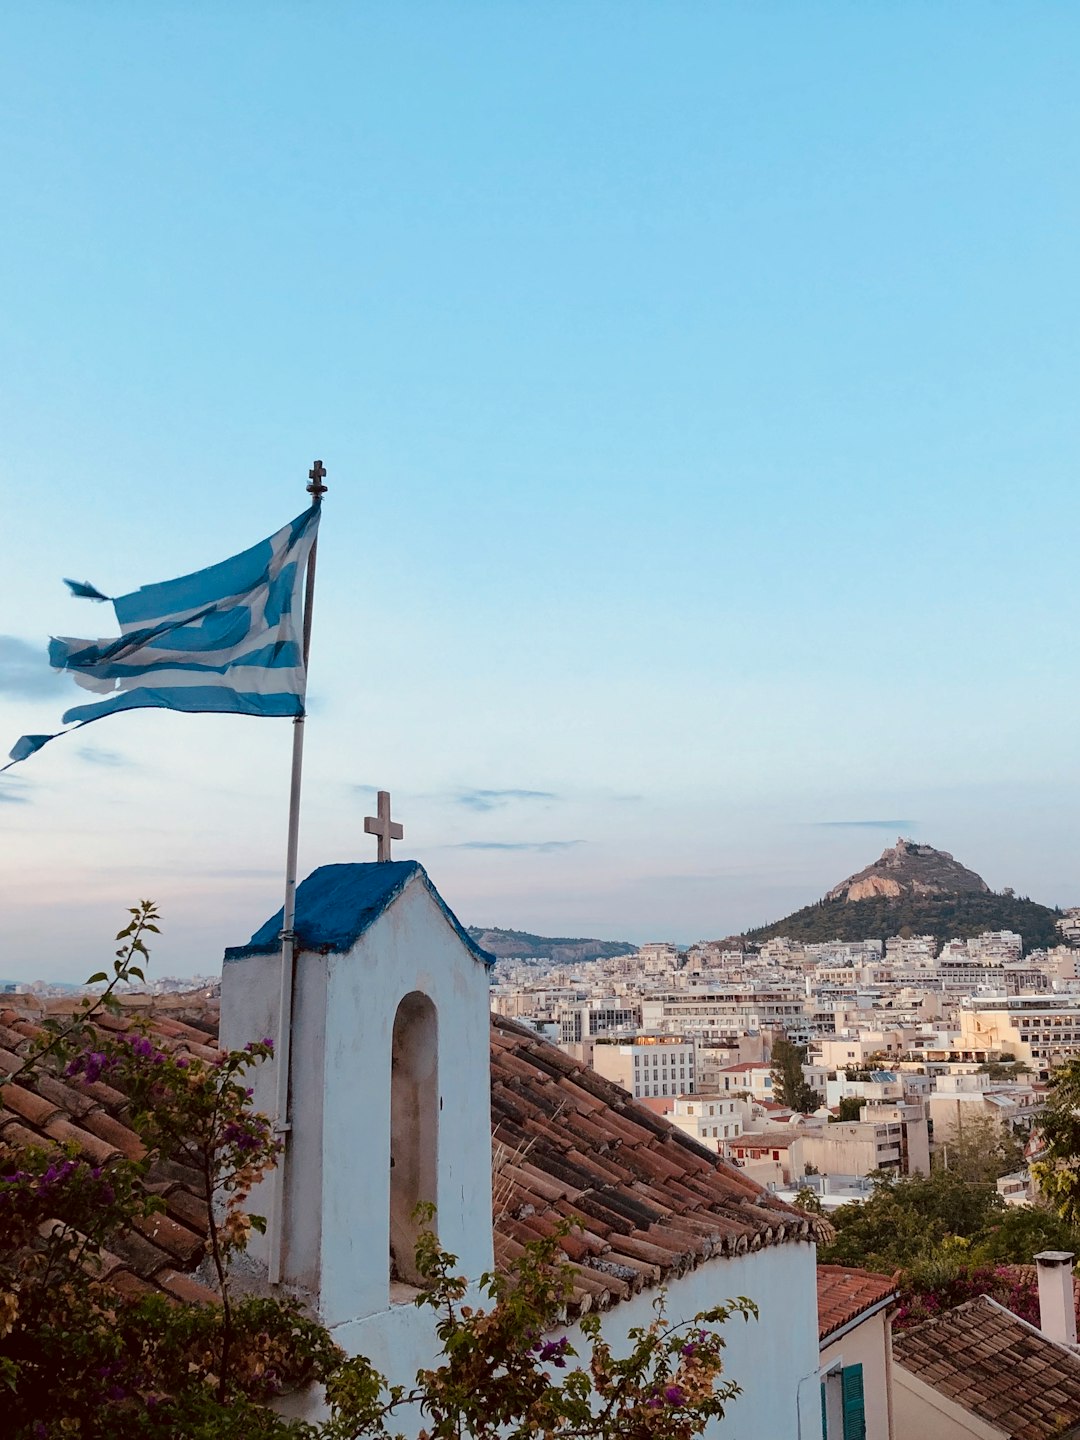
[269, 459, 327, 1284]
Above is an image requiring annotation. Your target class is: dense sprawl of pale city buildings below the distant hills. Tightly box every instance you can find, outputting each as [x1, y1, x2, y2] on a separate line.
[491, 910, 1080, 1211]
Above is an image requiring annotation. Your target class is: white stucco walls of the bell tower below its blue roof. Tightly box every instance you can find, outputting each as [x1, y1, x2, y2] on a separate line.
[222, 874, 492, 1324]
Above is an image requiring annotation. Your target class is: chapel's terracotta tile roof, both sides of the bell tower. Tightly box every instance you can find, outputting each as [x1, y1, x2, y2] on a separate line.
[0, 1002, 829, 1313]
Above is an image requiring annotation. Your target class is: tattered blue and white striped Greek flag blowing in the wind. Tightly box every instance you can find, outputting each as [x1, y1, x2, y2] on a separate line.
[10, 504, 320, 762]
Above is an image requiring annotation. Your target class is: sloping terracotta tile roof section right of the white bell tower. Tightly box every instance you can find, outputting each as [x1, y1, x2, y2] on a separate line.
[491, 1015, 827, 1310]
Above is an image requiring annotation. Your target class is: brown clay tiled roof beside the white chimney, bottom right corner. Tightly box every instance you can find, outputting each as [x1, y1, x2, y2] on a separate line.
[893, 1295, 1080, 1440]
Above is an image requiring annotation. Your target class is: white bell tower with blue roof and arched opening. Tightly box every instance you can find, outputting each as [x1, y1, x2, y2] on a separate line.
[222, 860, 492, 1364]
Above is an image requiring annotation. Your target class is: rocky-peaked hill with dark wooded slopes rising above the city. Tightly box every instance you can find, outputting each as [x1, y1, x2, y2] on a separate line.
[744, 840, 1061, 950]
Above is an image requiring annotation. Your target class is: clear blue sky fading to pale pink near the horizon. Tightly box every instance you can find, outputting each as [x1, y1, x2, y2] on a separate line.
[0, 0, 1080, 979]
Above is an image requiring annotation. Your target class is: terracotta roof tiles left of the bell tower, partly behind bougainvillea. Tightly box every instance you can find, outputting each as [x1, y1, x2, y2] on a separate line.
[0, 1008, 217, 1300]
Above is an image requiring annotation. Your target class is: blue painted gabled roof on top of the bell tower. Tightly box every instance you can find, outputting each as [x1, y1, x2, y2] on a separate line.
[225, 860, 495, 965]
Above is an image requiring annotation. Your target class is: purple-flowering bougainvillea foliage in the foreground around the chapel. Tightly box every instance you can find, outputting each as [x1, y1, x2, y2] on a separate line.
[0, 901, 756, 1440]
